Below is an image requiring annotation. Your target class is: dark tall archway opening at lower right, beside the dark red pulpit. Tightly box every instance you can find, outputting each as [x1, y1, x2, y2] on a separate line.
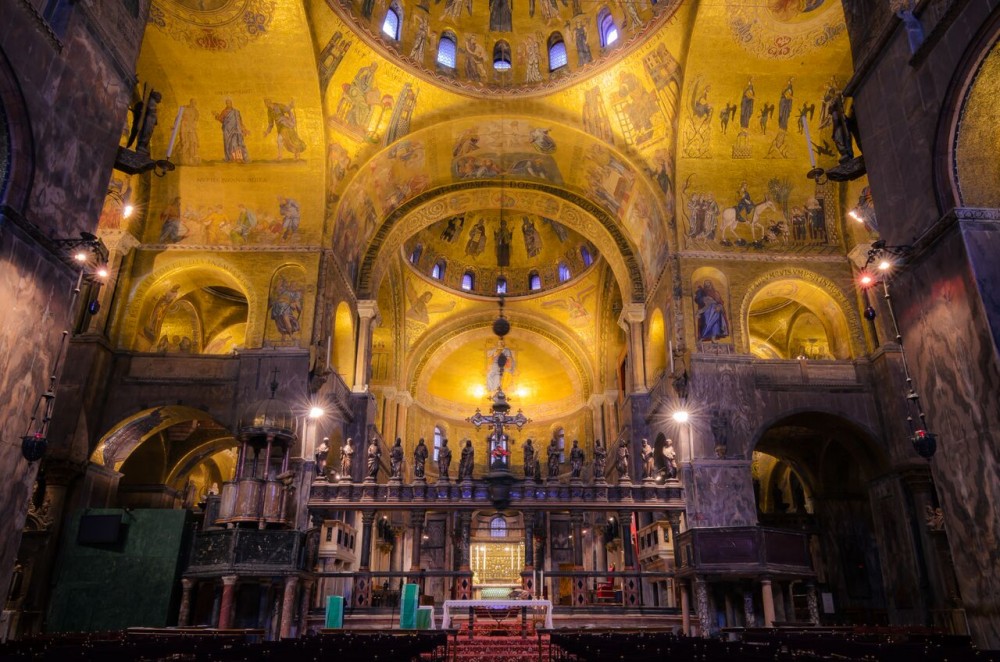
[751, 412, 893, 624]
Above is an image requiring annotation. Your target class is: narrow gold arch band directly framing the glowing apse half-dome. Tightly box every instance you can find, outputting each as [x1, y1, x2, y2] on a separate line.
[406, 310, 594, 399]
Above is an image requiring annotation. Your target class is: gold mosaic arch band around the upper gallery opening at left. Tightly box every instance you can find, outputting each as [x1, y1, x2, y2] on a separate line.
[118, 257, 264, 347]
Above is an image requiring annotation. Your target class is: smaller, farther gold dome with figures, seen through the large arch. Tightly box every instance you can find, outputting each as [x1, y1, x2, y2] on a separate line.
[403, 209, 598, 297]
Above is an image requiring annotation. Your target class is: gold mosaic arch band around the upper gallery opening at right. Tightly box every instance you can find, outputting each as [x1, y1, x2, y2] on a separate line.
[738, 267, 863, 359]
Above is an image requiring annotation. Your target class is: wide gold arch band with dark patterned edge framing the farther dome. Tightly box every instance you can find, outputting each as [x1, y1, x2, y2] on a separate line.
[358, 181, 646, 302]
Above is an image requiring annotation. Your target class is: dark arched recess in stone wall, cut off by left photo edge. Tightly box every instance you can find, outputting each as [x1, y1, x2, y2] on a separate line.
[0, 49, 35, 211]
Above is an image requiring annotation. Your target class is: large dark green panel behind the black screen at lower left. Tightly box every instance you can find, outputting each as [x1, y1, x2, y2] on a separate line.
[48, 509, 188, 632]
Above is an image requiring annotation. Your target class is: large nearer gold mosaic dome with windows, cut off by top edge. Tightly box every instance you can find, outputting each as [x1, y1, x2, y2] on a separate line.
[329, 0, 680, 93]
